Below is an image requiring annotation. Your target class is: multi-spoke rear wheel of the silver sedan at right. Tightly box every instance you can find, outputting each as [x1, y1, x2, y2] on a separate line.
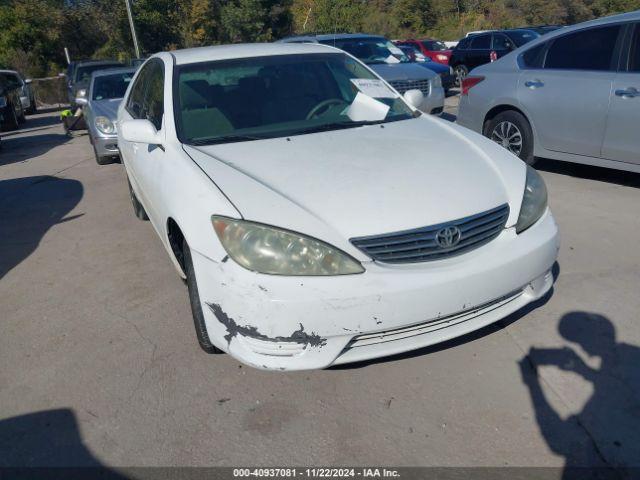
[484, 110, 535, 165]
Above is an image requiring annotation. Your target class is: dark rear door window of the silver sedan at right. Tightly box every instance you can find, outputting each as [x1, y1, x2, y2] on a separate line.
[544, 25, 620, 71]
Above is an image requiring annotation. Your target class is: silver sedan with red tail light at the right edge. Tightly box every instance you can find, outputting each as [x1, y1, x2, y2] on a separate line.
[458, 12, 640, 172]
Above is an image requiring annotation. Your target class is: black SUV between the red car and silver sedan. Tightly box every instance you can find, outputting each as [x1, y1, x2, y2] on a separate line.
[449, 29, 540, 83]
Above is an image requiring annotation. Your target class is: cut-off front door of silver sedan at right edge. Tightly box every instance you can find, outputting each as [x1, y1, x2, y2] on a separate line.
[602, 23, 640, 164]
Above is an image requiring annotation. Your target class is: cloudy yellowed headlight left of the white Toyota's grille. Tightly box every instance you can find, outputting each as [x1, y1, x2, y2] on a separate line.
[211, 215, 364, 275]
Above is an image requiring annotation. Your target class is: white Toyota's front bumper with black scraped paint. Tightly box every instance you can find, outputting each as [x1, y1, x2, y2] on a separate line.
[192, 211, 559, 370]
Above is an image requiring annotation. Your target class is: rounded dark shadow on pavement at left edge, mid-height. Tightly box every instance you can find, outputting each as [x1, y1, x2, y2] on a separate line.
[0, 176, 84, 279]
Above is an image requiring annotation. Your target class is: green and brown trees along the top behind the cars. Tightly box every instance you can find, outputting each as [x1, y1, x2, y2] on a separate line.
[0, 0, 640, 76]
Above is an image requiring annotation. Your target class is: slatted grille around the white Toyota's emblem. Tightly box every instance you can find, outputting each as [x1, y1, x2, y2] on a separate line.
[351, 204, 509, 263]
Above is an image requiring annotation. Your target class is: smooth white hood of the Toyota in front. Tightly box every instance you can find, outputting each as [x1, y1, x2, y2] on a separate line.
[184, 116, 525, 256]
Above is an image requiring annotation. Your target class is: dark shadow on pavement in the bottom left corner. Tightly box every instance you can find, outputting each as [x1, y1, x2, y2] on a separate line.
[0, 408, 127, 480]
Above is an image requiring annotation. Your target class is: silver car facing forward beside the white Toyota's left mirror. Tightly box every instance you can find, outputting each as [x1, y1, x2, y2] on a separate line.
[76, 67, 136, 165]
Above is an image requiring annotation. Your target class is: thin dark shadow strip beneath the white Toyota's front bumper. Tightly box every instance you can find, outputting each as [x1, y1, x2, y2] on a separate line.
[328, 262, 560, 370]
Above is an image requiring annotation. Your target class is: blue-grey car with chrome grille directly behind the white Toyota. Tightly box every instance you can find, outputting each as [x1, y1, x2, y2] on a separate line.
[279, 33, 444, 114]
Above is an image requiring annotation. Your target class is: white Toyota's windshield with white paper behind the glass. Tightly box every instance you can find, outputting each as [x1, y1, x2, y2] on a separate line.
[174, 53, 414, 145]
